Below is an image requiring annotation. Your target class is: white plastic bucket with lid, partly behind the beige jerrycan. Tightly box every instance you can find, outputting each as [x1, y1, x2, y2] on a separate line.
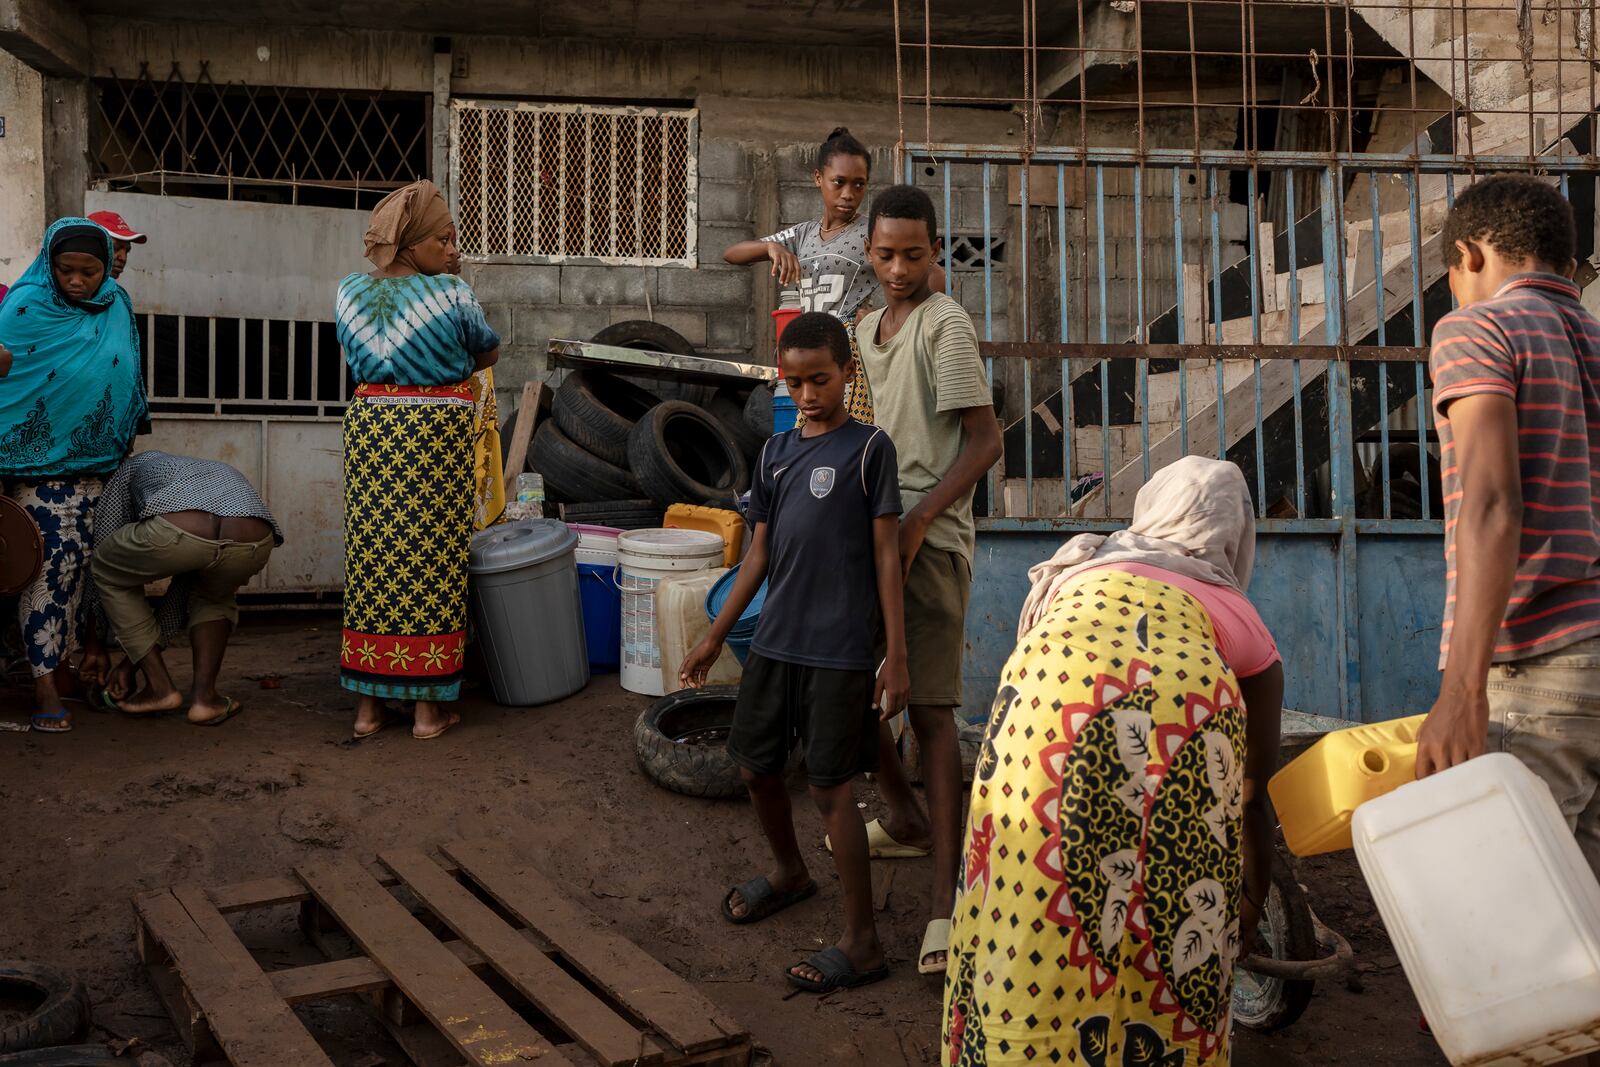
[616, 530, 723, 696]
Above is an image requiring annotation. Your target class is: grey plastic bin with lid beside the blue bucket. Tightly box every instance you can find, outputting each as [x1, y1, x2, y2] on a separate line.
[467, 518, 589, 705]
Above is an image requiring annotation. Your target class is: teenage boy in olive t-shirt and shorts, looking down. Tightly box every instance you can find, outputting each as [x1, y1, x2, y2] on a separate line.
[856, 186, 1000, 974]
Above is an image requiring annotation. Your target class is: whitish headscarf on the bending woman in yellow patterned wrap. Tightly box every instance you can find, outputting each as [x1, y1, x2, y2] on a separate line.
[1016, 456, 1256, 638]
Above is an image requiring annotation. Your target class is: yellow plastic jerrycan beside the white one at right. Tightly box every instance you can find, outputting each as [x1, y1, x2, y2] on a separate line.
[1267, 715, 1427, 856]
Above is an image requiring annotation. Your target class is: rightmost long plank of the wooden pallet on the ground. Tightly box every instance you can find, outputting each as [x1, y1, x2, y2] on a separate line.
[440, 840, 747, 1053]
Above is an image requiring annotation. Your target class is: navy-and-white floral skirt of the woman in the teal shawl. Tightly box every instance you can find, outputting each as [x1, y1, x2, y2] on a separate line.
[11, 475, 104, 678]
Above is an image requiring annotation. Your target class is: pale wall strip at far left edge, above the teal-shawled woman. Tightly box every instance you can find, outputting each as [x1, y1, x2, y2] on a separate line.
[0, 51, 46, 285]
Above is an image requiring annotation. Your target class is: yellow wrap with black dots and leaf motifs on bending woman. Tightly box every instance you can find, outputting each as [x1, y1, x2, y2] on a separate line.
[941, 569, 1245, 1067]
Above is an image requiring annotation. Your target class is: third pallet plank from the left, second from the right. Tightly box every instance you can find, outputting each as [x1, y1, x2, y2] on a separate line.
[378, 848, 661, 1065]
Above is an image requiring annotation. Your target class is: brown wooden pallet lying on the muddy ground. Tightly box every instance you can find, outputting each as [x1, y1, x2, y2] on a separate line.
[134, 841, 752, 1067]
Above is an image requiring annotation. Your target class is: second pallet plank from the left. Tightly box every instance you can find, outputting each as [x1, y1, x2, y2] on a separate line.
[294, 856, 568, 1065]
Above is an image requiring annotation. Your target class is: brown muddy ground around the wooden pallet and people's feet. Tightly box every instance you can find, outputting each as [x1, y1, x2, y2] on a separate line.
[0, 614, 1445, 1067]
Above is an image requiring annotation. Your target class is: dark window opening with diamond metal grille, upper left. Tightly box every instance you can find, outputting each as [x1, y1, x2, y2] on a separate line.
[91, 62, 430, 208]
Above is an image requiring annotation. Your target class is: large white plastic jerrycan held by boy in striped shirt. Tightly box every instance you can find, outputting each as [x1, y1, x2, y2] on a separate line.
[1352, 752, 1600, 1067]
